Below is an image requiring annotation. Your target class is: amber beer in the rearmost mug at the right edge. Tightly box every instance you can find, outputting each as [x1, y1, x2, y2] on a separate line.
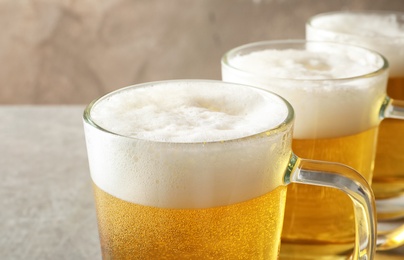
[372, 78, 404, 199]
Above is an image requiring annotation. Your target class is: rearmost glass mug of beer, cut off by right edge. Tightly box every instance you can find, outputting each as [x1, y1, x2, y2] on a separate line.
[306, 11, 404, 219]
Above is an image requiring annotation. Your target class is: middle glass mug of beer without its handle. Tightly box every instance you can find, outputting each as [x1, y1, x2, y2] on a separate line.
[222, 40, 400, 259]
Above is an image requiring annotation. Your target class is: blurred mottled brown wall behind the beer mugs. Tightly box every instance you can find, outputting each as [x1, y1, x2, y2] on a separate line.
[0, 0, 404, 104]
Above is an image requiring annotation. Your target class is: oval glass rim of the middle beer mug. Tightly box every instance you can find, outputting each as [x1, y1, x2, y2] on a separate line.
[221, 39, 389, 82]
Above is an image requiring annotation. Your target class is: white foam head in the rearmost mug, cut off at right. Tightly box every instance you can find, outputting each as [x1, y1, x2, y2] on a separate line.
[306, 12, 404, 77]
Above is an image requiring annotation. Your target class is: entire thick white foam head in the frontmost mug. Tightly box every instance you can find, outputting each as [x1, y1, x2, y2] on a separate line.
[85, 81, 291, 208]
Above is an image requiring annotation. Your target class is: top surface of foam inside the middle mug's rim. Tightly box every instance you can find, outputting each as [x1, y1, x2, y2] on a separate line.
[231, 48, 382, 80]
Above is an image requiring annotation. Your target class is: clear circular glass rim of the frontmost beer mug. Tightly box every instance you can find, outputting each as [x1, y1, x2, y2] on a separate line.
[83, 79, 294, 145]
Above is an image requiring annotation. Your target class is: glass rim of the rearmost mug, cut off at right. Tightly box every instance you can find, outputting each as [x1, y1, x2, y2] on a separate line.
[306, 10, 404, 41]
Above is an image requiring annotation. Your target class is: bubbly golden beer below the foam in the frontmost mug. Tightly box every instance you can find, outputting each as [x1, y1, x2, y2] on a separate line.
[94, 184, 286, 259]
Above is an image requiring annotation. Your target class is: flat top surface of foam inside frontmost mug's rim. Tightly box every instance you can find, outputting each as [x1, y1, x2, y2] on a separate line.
[91, 83, 288, 142]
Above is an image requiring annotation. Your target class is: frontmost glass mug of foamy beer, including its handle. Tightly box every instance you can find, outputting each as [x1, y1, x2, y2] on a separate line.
[84, 80, 376, 259]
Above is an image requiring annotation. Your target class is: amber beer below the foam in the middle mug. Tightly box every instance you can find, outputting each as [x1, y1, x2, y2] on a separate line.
[281, 128, 377, 259]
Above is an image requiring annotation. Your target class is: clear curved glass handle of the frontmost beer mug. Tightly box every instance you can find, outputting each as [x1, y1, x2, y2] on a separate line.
[285, 155, 376, 260]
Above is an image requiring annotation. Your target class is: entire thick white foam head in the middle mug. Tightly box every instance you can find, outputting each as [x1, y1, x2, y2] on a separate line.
[222, 47, 387, 139]
